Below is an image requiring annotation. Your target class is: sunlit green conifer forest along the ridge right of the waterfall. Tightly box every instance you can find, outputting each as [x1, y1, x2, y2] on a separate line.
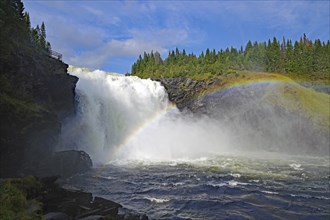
[131, 34, 330, 78]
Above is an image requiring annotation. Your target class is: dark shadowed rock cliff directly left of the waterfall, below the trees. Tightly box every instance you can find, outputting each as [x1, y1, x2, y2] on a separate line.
[0, 51, 88, 177]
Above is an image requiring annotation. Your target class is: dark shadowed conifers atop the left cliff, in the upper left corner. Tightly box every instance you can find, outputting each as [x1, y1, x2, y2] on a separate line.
[0, 0, 51, 62]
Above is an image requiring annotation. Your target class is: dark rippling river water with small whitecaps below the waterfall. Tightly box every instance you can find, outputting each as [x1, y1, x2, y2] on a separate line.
[64, 156, 330, 219]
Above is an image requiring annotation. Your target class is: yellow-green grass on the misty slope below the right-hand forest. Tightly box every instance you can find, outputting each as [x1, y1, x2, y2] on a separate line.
[204, 71, 330, 132]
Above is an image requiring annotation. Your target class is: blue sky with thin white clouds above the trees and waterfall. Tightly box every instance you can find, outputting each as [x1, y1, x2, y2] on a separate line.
[23, 0, 330, 73]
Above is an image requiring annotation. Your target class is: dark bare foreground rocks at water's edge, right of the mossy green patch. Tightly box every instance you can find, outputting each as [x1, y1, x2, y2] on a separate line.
[40, 177, 148, 220]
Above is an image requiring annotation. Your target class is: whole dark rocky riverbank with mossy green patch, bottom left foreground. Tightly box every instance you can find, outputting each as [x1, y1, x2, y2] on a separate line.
[0, 176, 148, 220]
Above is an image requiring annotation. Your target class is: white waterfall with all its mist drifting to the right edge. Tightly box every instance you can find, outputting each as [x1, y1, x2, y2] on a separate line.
[60, 68, 329, 163]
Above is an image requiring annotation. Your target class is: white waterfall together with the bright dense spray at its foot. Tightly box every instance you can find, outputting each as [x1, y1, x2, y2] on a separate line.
[61, 68, 232, 163]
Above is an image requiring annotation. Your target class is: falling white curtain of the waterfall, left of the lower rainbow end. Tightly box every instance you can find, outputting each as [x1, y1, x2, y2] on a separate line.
[62, 68, 170, 162]
